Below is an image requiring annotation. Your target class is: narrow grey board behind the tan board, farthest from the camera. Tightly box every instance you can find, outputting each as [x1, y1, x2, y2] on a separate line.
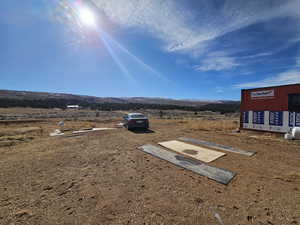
[178, 137, 256, 156]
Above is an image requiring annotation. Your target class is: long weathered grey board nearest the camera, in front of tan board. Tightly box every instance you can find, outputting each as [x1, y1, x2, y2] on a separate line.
[139, 145, 236, 184]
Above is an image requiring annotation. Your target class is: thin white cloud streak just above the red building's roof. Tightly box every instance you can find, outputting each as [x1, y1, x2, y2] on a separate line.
[234, 69, 300, 88]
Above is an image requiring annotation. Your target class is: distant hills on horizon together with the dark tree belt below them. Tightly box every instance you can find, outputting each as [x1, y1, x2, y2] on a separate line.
[0, 90, 239, 111]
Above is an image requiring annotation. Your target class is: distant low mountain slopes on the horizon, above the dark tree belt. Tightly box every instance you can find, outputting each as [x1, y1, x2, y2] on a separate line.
[0, 90, 239, 108]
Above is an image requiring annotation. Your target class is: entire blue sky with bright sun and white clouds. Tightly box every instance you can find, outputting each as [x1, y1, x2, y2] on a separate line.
[0, 0, 300, 100]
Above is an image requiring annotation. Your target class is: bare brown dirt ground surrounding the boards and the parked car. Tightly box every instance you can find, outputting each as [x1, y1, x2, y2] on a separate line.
[0, 110, 300, 225]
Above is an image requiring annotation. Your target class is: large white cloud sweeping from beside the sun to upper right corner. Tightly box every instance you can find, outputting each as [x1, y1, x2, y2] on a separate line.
[91, 0, 299, 51]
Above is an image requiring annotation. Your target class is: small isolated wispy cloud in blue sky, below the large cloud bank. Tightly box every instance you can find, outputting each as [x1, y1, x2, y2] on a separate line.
[194, 56, 239, 71]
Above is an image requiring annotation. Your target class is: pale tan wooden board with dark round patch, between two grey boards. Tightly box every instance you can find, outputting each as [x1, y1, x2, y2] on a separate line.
[158, 140, 226, 162]
